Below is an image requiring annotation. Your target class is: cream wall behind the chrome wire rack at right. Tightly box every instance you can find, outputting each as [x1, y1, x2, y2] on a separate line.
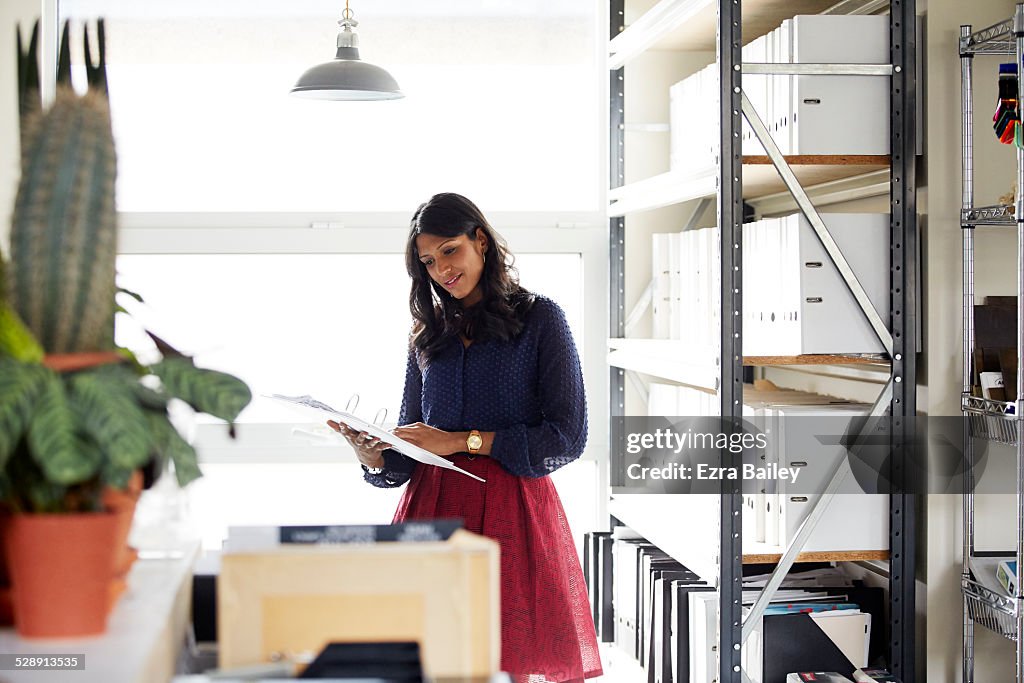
[922, 0, 1016, 683]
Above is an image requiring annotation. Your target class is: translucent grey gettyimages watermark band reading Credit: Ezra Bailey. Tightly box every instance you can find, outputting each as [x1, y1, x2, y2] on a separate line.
[611, 409, 1003, 496]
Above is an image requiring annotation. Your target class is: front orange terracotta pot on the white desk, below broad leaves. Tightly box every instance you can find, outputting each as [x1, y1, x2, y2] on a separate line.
[4, 512, 117, 638]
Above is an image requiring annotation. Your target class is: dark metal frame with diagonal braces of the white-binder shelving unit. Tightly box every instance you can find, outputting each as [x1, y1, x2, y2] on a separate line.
[609, 0, 921, 683]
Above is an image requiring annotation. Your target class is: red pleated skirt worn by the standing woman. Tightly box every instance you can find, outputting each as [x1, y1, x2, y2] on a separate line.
[394, 456, 602, 683]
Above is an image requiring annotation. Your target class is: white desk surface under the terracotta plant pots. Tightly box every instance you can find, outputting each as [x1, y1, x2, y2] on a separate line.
[0, 541, 200, 683]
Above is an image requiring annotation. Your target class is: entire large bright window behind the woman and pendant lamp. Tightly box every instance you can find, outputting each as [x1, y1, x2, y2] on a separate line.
[58, 0, 607, 547]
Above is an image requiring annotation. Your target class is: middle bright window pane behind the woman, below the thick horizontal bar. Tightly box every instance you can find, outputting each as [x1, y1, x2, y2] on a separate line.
[118, 254, 584, 431]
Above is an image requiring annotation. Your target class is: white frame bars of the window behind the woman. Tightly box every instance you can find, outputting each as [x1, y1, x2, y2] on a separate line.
[118, 212, 608, 471]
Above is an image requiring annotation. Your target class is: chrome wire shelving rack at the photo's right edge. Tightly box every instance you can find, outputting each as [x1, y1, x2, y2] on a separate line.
[959, 4, 1024, 683]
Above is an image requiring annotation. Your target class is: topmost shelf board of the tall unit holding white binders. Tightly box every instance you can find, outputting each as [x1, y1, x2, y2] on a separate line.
[611, 0, 836, 62]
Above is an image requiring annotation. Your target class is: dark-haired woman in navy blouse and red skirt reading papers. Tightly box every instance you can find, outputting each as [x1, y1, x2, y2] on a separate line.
[330, 194, 601, 683]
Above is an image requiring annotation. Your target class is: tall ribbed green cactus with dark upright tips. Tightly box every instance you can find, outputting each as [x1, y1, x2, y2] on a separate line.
[6, 20, 117, 353]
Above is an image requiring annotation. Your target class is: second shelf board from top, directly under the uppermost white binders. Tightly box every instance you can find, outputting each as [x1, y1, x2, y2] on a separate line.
[608, 162, 889, 216]
